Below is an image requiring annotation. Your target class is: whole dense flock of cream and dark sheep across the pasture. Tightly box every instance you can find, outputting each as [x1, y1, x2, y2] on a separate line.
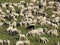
[0, 0, 60, 45]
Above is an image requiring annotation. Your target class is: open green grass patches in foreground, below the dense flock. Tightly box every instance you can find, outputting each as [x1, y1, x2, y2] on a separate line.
[0, 25, 60, 45]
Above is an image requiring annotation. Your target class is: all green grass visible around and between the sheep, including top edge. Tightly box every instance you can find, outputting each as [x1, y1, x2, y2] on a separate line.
[0, 0, 60, 45]
